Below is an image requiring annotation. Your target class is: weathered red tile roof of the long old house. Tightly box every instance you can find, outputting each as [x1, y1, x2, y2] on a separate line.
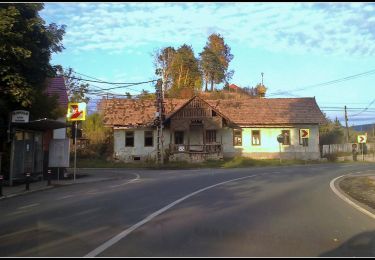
[100, 98, 325, 127]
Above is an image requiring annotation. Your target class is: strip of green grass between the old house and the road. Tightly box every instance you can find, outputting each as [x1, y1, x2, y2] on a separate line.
[71, 157, 323, 169]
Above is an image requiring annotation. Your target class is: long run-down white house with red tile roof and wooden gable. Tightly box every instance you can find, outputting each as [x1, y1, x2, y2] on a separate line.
[100, 96, 325, 162]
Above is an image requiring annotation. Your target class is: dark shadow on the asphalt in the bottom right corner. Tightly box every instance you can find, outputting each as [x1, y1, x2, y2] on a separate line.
[320, 231, 375, 257]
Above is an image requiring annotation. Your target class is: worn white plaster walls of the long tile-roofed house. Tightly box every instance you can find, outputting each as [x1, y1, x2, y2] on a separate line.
[114, 125, 320, 162]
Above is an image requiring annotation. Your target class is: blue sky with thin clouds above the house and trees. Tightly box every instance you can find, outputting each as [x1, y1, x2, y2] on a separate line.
[40, 2, 375, 125]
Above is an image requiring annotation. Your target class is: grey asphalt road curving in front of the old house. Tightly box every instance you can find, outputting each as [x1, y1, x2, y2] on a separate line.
[0, 163, 375, 257]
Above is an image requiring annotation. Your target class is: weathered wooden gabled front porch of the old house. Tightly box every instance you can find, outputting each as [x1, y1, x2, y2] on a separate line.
[165, 97, 231, 162]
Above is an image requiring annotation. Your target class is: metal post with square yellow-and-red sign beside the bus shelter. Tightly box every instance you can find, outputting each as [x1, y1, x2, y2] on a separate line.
[66, 102, 86, 181]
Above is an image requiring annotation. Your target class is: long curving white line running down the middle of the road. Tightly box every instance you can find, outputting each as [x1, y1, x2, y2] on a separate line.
[85, 175, 258, 257]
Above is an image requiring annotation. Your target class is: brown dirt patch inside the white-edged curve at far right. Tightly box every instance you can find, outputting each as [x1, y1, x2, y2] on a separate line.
[339, 176, 375, 209]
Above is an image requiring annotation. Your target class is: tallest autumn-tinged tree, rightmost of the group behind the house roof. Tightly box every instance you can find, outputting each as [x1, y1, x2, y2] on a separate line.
[200, 33, 234, 91]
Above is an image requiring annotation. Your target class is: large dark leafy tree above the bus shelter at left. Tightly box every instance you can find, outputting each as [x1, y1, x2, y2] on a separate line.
[0, 3, 65, 123]
